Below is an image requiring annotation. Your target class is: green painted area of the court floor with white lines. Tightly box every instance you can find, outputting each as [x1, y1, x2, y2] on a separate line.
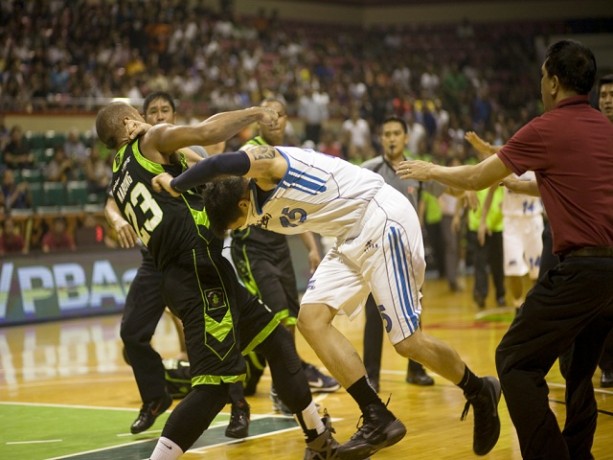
[0, 401, 298, 460]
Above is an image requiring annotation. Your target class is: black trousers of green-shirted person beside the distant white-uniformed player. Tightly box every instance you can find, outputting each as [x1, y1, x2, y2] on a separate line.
[467, 231, 505, 299]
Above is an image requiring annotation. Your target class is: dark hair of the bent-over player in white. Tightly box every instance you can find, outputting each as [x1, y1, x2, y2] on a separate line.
[202, 176, 245, 238]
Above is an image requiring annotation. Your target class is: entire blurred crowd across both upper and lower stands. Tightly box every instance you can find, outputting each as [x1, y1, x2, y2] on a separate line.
[0, 0, 610, 266]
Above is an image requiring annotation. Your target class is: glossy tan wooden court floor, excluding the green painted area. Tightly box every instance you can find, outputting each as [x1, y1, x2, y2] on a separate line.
[0, 279, 613, 460]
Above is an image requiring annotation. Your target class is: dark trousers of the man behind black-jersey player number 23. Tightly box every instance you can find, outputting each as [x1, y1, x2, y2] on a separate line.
[120, 256, 166, 402]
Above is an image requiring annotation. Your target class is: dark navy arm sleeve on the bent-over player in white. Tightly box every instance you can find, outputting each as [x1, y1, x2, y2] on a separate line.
[170, 150, 251, 193]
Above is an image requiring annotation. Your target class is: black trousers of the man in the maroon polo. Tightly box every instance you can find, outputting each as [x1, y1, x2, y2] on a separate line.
[496, 257, 613, 460]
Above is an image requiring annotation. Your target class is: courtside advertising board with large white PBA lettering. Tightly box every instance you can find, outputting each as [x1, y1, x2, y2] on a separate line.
[0, 250, 141, 326]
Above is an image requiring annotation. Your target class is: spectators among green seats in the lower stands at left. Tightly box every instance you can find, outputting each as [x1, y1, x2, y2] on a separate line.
[0, 115, 115, 255]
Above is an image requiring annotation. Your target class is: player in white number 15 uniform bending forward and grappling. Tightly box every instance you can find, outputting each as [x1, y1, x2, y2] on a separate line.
[153, 145, 500, 459]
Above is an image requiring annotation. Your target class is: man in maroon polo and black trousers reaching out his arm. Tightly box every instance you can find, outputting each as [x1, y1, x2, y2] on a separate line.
[398, 40, 613, 460]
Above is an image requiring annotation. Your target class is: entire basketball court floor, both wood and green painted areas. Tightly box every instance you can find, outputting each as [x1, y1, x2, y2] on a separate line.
[0, 280, 613, 460]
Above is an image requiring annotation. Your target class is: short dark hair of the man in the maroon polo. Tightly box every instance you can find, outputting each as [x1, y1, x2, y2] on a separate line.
[545, 40, 597, 95]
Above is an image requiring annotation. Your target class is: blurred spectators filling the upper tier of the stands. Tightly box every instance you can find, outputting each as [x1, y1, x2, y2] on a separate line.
[0, 0, 606, 120]
